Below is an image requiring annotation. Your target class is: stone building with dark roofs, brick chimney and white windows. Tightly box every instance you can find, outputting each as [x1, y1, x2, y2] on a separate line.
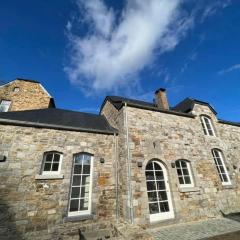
[0, 80, 240, 239]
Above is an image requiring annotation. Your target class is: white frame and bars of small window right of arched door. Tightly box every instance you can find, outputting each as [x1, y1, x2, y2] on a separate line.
[175, 159, 194, 188]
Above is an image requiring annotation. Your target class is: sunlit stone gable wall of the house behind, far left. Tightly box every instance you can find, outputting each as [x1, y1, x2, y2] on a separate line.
[0, 80, 51, 111]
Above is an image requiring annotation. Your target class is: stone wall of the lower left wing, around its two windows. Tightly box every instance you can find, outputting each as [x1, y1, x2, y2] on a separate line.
[0, 125, 116, 239]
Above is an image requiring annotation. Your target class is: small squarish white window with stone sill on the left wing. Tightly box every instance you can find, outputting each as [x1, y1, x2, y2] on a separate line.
[42, 152, 62, 174]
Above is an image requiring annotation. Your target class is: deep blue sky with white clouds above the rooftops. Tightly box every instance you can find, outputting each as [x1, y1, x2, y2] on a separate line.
[0, 0, 240, 122]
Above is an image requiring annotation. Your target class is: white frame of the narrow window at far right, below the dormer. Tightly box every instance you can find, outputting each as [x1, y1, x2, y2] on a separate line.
[212, 149, 231, 185]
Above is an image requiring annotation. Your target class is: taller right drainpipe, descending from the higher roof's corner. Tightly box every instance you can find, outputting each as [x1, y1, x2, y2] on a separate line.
[124, 102, 133, 224]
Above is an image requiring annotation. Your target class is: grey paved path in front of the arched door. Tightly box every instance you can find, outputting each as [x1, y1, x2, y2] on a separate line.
[149, 218, 240, 240]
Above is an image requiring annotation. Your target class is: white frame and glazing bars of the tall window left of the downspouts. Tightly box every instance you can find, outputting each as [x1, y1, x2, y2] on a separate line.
[68, 152, 93, 217]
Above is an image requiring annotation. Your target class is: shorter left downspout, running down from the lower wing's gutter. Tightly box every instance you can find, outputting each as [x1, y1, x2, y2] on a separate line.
[114, 133, 119, 223]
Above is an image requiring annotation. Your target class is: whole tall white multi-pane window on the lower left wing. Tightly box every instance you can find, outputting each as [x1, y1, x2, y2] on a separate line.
[68, 153, 93, 216]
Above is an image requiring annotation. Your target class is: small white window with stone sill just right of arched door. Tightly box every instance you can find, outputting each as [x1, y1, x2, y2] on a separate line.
[176, 160, 194, 187]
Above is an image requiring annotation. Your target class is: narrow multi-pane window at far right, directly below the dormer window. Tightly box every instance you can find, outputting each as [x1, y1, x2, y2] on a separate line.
[212, 149, 231, 185]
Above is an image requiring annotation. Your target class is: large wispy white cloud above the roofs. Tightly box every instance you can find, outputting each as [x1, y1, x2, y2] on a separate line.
[65, 0, 193, 94]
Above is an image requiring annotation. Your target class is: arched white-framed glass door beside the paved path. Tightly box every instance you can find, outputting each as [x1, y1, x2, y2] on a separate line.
[145, 160, 174, 222]
